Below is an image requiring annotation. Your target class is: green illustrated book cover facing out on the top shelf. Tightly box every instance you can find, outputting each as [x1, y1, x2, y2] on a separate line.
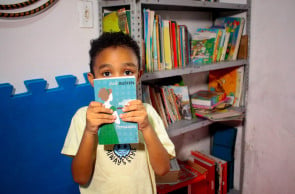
[190, 31, 216, 64]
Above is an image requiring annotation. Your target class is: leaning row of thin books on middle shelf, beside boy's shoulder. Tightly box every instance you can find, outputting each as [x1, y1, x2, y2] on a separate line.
[143, 85, 192, 127]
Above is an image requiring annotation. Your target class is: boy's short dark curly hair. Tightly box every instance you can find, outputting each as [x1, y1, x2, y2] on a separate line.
[89, 32, 140, 75]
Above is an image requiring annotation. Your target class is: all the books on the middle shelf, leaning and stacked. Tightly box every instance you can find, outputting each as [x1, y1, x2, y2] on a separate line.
[143, 66, 244, 124]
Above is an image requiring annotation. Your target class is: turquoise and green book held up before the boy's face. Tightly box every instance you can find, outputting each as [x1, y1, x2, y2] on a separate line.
[94, 76, 138, 144]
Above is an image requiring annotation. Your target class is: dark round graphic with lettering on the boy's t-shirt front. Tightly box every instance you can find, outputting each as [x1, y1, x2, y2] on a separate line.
[106, 144, 136, 165]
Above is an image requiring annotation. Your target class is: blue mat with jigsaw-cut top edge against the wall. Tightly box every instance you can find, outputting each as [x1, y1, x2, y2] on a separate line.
[0, 74, 93, 194]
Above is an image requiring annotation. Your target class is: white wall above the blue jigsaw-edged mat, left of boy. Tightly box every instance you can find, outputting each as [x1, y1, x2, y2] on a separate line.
[0, 0, 98, 93]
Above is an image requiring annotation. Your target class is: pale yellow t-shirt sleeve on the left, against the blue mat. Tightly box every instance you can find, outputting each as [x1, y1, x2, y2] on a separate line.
[61, 107, 87, 156]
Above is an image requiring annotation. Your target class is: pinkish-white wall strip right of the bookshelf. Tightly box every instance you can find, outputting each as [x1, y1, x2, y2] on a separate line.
[244, 0, 295, 194]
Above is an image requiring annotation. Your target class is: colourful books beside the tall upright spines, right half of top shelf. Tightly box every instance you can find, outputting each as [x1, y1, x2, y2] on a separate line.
[191, 17, 245, 64]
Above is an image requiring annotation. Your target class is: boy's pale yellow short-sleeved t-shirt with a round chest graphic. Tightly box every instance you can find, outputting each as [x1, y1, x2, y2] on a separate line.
[62, 104, 175, 194]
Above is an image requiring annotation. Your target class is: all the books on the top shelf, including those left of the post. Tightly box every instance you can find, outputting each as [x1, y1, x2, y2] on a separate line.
[103, 8, 247, 72]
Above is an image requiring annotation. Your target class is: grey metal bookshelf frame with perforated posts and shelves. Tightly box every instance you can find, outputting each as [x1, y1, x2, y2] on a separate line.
[98, 0, 251, 193]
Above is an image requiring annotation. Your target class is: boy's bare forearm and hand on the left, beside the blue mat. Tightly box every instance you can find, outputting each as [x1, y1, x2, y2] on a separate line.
[72, 102, 115, 185]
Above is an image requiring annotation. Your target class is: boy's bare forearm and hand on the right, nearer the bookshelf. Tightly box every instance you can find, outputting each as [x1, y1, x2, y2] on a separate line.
[120, 100, 170, 175]
